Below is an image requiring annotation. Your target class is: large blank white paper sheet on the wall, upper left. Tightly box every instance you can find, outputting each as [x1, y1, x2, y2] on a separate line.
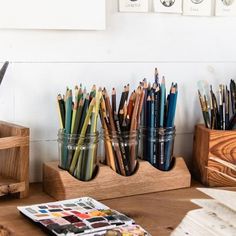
[0, 0, 106, 30]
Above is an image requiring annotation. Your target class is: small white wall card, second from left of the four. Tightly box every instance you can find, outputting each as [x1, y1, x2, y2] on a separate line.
[154, 0, 182, 13]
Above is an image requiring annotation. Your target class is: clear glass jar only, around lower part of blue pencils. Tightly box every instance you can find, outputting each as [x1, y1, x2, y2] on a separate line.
[139, 127, 176, 171]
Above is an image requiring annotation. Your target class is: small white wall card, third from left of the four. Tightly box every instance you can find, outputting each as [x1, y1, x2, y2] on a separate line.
[183, 0, 212, 16]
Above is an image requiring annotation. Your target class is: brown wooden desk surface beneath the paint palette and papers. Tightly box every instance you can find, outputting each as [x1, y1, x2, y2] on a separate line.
[0, 182, 207, 236]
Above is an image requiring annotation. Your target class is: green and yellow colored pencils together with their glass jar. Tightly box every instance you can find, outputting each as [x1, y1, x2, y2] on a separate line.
[57, 85, 102, 180]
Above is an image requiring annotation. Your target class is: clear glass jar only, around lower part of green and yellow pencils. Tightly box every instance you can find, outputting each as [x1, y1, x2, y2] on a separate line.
[58, 129, 99, 181]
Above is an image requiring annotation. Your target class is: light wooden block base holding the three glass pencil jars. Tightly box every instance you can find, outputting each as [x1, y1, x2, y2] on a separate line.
[43, 157, 191, 200]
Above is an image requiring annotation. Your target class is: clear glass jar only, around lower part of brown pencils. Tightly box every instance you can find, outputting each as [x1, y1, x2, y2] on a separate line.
[102, 130, 139, 176]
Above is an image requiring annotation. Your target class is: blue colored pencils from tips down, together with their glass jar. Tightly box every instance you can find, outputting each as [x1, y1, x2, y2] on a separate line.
[139, 69, 178, 171]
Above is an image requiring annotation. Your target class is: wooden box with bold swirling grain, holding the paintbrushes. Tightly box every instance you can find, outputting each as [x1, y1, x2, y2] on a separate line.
[191, 125, 236, 187]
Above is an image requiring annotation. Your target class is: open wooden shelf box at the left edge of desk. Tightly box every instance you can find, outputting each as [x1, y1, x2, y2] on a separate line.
[0, 121, 29, 198]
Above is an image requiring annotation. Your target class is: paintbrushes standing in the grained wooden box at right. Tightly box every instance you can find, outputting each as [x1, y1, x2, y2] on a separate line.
[198, 80, 236, 130]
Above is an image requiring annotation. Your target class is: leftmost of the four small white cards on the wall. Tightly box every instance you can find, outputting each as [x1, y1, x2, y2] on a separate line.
[119, 0, 148, 12]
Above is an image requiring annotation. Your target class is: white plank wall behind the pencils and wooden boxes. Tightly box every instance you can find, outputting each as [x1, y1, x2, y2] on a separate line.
[0, 0, 236, 181]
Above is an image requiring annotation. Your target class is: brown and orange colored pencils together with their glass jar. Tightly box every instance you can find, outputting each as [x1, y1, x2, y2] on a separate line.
[100, 85, 144, 176]
